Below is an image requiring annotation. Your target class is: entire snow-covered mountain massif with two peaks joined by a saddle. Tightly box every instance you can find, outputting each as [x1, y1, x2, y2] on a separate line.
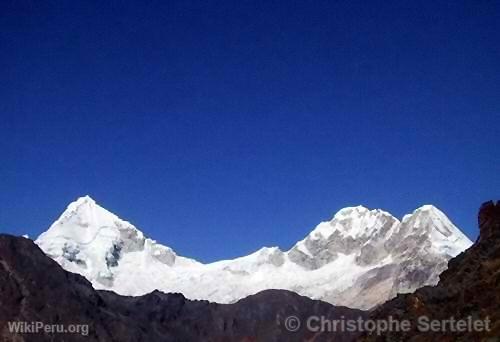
[36, 196, 472, 309]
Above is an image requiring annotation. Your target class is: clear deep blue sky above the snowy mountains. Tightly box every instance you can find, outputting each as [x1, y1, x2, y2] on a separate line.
[0, 0, 500, 261]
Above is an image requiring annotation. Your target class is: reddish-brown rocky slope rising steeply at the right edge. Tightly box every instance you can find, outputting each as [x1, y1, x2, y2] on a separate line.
[362, 202, 500, 341]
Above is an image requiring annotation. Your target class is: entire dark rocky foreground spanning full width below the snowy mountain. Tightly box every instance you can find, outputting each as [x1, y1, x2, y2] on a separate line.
[0, 202, 500, 342]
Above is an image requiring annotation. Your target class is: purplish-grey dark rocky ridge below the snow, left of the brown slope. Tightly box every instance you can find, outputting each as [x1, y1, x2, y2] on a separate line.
[0, 235, 367, 342]
